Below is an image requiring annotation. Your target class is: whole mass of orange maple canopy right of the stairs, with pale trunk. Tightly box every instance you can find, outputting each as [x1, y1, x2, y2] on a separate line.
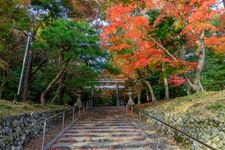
[101, 0, 224, 101]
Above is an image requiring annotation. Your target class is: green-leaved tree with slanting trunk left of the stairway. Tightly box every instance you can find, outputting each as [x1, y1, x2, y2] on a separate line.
[37, 19, 102, 104]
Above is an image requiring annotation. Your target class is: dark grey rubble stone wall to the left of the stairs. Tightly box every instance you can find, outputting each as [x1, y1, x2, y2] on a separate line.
[0, 110, 62, 150]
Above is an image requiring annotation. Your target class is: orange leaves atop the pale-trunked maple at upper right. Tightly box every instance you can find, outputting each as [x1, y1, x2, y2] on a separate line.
[155, 0, 221, 37]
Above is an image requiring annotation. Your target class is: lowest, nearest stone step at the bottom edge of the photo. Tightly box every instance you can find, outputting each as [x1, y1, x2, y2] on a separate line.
[52, 141, 150, 150]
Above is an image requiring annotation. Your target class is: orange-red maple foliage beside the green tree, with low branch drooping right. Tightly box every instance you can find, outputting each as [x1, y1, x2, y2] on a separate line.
[101, 0, 198, 81]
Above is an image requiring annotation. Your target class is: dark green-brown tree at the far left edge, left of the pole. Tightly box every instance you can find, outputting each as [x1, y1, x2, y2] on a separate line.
[0, 0, 29, 98]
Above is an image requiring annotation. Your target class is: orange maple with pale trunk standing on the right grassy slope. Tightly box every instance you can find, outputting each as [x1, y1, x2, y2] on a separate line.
[152, 0, 224, 92]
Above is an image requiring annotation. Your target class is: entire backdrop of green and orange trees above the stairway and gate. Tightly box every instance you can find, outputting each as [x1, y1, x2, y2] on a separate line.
[0, 0, 225, 104]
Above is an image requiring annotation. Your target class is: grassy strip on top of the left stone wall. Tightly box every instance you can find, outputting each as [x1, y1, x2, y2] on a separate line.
[0, 100, 64, 117]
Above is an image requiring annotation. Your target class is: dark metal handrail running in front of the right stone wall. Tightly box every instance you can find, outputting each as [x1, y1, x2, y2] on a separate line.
[139, 110, 216, 150]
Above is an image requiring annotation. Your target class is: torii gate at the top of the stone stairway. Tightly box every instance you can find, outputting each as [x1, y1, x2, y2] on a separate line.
[86, 79, 125, 106]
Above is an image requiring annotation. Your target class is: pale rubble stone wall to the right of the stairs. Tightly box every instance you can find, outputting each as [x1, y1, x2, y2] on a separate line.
[143, 110, 225, 150]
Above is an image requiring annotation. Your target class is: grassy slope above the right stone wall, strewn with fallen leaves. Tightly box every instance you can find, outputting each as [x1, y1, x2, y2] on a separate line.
[142, 91, 225, 118]
